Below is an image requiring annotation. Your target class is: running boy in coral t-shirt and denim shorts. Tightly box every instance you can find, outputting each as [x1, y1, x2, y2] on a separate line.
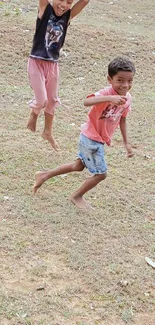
[33, 57, 135, 209]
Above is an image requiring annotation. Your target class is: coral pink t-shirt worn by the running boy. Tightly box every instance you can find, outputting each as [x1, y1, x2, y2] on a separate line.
[81, 86, 131, 145]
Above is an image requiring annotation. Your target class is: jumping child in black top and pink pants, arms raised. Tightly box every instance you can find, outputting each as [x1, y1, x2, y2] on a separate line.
[27, 0, 89, 151]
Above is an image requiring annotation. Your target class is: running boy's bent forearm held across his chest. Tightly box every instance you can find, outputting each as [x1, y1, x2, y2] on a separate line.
[84, 95, 127, 106]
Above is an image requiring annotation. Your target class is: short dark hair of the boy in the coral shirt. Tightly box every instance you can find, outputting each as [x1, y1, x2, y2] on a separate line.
[108, 57, 136, 78]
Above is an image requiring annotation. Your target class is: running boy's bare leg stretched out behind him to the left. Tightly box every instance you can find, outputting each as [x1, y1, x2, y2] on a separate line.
[33, 159, 84, 194]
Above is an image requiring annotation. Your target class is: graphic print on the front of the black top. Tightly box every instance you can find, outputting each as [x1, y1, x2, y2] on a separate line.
[45, 14, 63, 51]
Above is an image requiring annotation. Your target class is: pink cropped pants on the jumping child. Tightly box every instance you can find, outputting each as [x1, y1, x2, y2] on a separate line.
[28, 58, 59, 115]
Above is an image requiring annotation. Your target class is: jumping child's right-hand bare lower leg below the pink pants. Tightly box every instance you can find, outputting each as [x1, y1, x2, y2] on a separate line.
[41, 112, 59, 151]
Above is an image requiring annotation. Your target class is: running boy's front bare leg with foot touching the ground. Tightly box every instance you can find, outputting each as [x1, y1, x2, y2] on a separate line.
[70, 173, 107, 209]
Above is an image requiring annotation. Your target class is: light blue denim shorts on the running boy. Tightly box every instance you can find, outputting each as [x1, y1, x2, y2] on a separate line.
[78, 133, 107, 174]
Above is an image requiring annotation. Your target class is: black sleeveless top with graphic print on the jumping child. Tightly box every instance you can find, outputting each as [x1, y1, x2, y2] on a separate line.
[30, 4, 70, 62]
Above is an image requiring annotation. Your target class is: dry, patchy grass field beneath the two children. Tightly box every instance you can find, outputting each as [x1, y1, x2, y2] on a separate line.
[0, 0, 155, 325]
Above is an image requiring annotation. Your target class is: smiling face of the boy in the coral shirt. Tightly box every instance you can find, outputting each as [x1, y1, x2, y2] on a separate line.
[108, 71, 134, 96]
